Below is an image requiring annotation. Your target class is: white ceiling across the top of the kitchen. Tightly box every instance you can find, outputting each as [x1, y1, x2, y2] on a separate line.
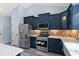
[0, 3, 69, 16]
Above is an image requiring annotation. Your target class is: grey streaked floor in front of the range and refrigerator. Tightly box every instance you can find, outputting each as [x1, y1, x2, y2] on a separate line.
[21, 48, 60, 56]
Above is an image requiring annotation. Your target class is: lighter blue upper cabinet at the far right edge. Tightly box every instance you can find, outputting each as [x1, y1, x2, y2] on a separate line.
[72, 3, 79, 30]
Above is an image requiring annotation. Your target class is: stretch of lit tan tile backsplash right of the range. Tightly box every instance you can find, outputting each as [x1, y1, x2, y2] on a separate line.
[49, 30, 78, 38]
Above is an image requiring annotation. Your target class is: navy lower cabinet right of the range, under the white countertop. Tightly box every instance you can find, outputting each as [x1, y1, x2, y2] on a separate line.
[48, 38, 65, 56]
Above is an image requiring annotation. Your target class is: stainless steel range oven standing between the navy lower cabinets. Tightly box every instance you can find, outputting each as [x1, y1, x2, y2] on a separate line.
[36, 37, 48, 52]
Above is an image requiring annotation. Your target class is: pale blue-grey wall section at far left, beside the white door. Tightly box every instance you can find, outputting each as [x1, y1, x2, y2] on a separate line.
[3, 17, 11, 43]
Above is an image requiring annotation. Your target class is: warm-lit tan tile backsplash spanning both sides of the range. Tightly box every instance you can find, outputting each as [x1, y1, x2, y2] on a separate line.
[30, 30, 79, 38]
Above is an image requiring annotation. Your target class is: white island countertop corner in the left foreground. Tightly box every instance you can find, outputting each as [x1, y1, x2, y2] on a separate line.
[0, 43, 23, 56]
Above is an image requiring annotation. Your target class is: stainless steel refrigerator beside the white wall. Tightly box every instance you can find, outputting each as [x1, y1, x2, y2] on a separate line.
[19, 24, 30, 49]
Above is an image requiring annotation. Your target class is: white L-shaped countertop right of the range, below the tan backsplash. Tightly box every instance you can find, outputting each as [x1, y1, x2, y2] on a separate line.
[48, 36, 79, 56]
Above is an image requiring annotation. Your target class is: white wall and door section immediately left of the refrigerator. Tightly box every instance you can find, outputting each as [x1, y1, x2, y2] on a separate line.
[10, 6, 24, 46]
